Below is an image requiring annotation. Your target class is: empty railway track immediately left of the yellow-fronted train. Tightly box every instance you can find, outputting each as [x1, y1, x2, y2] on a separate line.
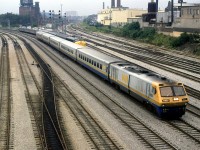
[28, 36, 176, 149]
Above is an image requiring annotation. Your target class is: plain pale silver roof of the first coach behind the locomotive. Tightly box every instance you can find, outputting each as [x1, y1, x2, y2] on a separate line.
[78, 47, 123, 63]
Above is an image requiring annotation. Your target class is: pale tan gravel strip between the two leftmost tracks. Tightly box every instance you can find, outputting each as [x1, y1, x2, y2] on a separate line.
[6, 35, 37, 150]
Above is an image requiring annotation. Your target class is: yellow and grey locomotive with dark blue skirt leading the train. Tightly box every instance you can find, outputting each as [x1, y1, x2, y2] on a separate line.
[110, 63, 188, 117]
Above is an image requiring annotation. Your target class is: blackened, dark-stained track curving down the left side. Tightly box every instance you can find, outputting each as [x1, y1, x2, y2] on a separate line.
[22, 39, 67, 150]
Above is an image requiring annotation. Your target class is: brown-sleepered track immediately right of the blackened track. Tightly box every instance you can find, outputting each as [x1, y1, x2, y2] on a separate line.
[54, 75, 123, 149]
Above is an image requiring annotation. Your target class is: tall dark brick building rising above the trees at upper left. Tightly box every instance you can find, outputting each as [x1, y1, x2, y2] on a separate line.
[19, 0, 41, 22]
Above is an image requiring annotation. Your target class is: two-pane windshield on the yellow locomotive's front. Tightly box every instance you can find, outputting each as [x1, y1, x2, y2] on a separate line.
[160, 86, 186, 97]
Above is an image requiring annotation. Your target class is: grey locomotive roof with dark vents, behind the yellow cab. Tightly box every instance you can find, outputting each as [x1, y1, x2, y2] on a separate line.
[112, 62, 175, 84]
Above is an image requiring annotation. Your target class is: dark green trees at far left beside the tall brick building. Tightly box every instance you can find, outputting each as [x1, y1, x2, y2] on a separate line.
[0, 13, 31, 27]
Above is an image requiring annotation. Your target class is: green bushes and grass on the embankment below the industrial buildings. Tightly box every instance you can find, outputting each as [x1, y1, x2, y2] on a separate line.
[82, 22, 200, 55]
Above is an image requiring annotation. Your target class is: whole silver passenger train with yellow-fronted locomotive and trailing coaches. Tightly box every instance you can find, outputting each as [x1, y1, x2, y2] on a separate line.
[36, 32, 189, 118]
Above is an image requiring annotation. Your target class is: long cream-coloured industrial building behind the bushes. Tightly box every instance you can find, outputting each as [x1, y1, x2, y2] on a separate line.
[97, 7, 147, 27]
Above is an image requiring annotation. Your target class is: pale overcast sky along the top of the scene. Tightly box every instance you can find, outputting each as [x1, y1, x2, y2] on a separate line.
[0, 0, 200, 15]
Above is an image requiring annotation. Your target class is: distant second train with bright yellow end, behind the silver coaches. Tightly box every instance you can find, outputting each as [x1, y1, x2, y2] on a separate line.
[19, 27, 86, 46]
